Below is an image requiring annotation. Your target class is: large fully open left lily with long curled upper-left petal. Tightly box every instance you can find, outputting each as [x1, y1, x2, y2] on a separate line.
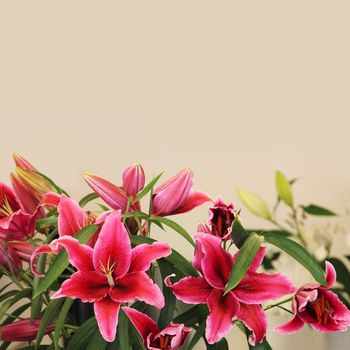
[31, 211, 171, 342]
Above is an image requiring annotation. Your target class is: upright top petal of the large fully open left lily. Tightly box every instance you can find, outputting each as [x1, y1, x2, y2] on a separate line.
[93, 211, 131, 279]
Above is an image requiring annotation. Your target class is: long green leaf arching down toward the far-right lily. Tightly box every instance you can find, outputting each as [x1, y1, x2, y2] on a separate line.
[263, 232, 327, 285]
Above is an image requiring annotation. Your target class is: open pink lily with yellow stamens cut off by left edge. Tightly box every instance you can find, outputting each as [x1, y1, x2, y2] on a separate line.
[0, 183, 35, 240]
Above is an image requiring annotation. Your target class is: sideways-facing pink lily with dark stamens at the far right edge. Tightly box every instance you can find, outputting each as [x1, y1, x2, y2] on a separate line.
[275, 261, 350, 333]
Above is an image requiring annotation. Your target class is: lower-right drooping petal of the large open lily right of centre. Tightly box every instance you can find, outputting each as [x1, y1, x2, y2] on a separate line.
[237, 303, 267, 345]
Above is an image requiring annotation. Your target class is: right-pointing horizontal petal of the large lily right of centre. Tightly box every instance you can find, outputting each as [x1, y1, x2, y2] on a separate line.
[232, 272, 295, 304]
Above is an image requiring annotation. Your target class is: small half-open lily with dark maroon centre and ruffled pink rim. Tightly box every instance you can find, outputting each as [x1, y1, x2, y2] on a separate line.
[197, 197, 236, 241]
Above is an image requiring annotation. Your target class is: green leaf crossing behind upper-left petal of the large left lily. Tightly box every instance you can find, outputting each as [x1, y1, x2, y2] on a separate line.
[33, 225, 98, 298]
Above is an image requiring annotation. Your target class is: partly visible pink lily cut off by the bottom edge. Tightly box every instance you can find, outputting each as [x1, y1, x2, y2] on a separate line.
[123, 307, 191, 350]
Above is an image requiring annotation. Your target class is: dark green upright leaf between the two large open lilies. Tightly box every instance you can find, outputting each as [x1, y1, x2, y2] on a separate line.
[158, 258, 176, 329]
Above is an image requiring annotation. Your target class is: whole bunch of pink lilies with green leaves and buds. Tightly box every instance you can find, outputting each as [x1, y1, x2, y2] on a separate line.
[0, 155, 350, 350]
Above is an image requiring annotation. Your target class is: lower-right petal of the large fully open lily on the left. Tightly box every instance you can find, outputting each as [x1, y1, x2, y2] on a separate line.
[109, 272, 164, 309]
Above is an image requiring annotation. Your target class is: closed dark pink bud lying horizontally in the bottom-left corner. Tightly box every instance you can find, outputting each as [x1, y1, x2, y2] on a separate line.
[0, 319, 55, 342]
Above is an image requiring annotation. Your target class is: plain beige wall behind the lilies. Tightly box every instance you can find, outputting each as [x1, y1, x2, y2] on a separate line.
[0, 0, 350, 349]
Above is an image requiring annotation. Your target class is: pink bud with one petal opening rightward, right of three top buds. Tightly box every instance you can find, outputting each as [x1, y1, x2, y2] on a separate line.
[152, 168, 211, 216]
